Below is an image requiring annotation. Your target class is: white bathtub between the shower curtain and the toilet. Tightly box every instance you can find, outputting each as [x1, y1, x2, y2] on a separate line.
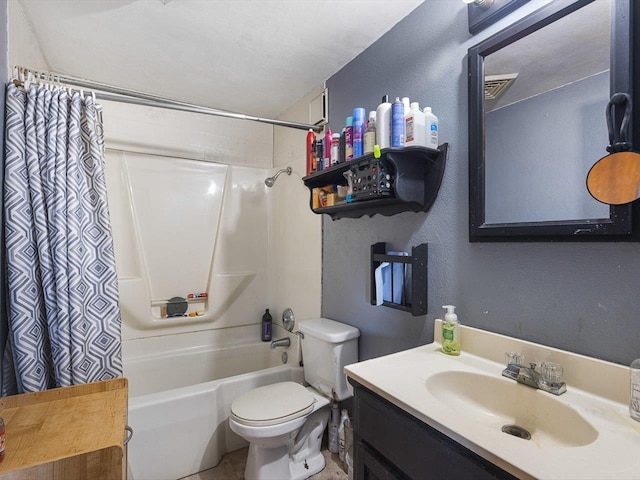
[123, 326, 303, 480]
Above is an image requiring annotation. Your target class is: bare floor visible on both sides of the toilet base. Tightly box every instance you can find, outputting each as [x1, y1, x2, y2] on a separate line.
[182, 447, 348, 480]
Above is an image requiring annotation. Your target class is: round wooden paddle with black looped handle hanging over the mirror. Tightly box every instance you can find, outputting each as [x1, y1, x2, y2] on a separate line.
[587, 93, 640, 205]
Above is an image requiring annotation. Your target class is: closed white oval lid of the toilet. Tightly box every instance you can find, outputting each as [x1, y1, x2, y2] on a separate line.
[231, 382, 315, 426]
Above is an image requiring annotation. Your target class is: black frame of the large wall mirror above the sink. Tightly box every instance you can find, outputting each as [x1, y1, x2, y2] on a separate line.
[468, 0, 640, 242]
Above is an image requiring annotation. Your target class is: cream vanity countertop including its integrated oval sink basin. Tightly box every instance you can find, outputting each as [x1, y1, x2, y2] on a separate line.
[345, 320, 640, 480]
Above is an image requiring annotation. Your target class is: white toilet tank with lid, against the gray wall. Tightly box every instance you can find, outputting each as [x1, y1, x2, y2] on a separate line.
[299, 318, 360, 400]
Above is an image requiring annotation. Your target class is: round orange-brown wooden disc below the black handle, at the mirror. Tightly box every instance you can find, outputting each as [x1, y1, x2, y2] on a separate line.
[587, 152, 640, 205]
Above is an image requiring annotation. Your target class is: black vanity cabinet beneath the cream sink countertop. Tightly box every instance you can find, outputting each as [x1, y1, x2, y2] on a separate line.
[349, 379, 516, 480]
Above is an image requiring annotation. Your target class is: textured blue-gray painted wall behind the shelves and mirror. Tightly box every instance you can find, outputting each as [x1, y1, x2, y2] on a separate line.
[322, 0, 640, 364]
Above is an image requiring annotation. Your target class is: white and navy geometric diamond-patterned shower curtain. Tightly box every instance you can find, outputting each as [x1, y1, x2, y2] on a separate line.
[1, 84, 122, 395]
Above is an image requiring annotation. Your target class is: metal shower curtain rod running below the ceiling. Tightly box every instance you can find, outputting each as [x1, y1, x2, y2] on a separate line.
[15, 66, 322, 132]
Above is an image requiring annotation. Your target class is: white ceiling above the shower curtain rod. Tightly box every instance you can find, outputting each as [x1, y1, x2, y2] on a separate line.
[19, 0, 424, 117]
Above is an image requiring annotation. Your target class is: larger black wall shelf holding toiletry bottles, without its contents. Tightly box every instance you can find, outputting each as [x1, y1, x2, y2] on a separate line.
[302, 143, 449, 220]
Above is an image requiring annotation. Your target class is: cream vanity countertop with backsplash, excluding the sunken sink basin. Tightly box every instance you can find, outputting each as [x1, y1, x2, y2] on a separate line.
[345, 321, 640, 480]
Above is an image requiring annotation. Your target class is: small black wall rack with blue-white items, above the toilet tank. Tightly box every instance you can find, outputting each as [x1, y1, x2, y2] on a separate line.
[371, 242, 429, 316]
